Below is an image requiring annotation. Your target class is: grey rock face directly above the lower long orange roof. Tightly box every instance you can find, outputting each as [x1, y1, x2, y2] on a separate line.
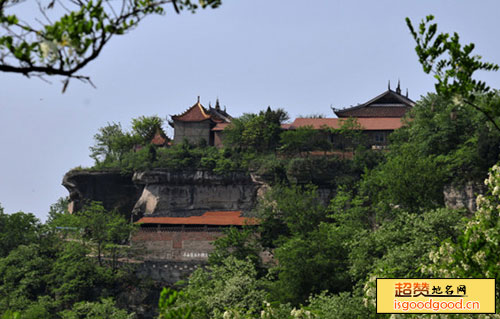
[133, 170, 258, 219]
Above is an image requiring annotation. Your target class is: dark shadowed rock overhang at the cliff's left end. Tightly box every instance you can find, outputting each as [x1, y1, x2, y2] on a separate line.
[62, 170, 144, 217]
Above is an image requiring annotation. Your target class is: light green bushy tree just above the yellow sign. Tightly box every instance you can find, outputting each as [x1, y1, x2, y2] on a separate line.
[346, 208, 467, 285]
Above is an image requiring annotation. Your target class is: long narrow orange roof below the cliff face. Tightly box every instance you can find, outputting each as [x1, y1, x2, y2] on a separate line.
[137, 211, 259, 226]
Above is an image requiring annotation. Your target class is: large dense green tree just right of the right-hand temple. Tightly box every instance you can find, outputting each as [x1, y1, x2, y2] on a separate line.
[362, 93, 500, 211]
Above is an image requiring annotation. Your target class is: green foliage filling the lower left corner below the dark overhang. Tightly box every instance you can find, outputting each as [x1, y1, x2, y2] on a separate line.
[0, 201, 137, 319]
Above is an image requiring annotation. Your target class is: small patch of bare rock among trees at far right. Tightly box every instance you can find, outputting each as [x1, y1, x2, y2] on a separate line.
[443, 182, 486, 213]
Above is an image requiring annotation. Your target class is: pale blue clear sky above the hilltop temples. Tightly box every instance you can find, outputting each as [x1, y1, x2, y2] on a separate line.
[0, 0, 500, 221]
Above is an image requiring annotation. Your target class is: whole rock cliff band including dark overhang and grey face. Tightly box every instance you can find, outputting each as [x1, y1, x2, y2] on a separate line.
[63, 170, 263, 221]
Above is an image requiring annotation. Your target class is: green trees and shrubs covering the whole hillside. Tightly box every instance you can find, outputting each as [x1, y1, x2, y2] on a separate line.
[0, 89, 500, 319]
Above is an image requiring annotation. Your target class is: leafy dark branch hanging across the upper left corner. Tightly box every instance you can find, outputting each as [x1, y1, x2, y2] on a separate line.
[0, 0, 221, 92]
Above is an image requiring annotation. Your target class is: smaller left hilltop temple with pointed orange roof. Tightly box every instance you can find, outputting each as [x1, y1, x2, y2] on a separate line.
[169, 97, 231, 146]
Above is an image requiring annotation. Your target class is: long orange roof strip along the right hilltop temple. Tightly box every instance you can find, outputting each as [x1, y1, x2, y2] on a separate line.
[290, 117, 403, 131]
